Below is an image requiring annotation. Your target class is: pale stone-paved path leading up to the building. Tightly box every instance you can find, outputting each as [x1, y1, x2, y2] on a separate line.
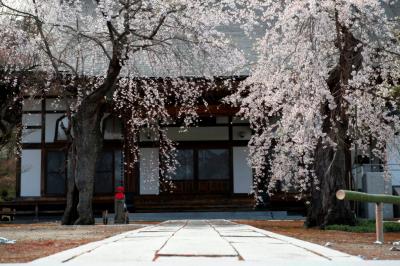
[26, 220, 374, 266]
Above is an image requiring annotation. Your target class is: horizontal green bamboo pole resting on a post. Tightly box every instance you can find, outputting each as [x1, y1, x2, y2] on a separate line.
[336, 190, 400, 205]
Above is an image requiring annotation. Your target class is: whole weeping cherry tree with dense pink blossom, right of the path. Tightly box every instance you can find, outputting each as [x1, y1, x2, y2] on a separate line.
[229, 0, 400, 227]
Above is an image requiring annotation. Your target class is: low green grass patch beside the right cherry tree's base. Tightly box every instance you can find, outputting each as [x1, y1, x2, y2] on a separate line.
[325, 220, 400, 233]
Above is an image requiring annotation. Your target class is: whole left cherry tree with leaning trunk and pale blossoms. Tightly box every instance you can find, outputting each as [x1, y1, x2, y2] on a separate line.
[0, 0, 243, 224]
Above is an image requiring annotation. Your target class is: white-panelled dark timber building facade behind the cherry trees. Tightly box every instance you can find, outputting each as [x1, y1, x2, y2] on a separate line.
[17, 88, 268, 213]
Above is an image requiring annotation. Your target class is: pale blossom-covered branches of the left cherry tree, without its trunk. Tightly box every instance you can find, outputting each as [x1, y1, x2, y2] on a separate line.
[0, 0, 245, 189]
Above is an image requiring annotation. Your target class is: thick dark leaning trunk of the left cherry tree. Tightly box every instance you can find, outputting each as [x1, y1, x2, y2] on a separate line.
[62, 53, 121, 225]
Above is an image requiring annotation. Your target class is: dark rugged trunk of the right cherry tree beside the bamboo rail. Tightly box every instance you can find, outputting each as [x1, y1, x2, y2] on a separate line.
[305, 22, 362, 228]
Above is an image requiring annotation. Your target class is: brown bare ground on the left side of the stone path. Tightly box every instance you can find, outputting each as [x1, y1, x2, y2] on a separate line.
[0, 223, 155, 263]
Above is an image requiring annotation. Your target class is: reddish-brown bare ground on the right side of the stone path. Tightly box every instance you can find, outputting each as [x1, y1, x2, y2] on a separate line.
[236, 220, 400, 260]
